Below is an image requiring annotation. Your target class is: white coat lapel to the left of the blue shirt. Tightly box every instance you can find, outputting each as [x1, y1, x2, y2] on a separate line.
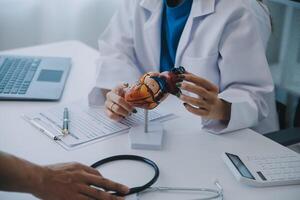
[140, 0, 163, 71]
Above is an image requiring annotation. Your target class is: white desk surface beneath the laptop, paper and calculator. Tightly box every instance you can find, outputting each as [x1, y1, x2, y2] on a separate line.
[0, 41, 300, 200]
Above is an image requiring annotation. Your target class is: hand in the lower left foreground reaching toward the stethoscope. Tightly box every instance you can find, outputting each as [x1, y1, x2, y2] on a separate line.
[34, 163, 129, 200]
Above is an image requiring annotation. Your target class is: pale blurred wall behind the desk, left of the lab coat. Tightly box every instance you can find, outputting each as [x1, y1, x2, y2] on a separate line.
[0, 0, 122, 50]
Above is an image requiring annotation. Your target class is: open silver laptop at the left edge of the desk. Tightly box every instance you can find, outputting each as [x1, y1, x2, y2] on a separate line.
[0, 55, 71, 101]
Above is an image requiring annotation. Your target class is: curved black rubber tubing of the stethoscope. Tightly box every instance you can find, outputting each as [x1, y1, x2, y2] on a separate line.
[91, 155, 159, 196]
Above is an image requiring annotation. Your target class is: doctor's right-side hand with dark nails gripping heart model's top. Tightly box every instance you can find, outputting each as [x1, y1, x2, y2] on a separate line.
[177, 73, 231, 121]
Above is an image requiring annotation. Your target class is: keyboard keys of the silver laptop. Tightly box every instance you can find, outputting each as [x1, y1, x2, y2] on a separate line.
[0, 58, 41, 95]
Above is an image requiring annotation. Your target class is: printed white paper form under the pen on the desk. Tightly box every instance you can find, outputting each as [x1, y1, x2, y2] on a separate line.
[24, 104, 172, 149]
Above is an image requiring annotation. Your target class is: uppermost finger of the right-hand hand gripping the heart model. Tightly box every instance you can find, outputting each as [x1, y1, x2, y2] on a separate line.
[179, 73, 219, 93]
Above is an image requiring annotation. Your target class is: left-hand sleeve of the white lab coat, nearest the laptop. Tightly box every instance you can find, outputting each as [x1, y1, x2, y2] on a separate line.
[96, 0, 141, 89]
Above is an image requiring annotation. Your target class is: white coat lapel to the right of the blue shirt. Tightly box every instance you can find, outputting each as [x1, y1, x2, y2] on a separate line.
[175, 0, 215, 67]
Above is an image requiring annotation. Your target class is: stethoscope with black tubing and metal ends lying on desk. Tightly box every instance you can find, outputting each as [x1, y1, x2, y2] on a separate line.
[91, 155, 223, 200]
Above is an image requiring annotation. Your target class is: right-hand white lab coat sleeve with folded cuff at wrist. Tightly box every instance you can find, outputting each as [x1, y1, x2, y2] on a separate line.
[202, 7, 274, 134]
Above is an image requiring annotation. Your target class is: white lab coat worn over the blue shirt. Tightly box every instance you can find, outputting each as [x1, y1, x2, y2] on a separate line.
[97, 0, 278, 134]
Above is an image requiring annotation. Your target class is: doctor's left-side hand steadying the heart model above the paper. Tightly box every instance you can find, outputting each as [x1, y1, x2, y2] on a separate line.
[105, 84, 137, 121]
